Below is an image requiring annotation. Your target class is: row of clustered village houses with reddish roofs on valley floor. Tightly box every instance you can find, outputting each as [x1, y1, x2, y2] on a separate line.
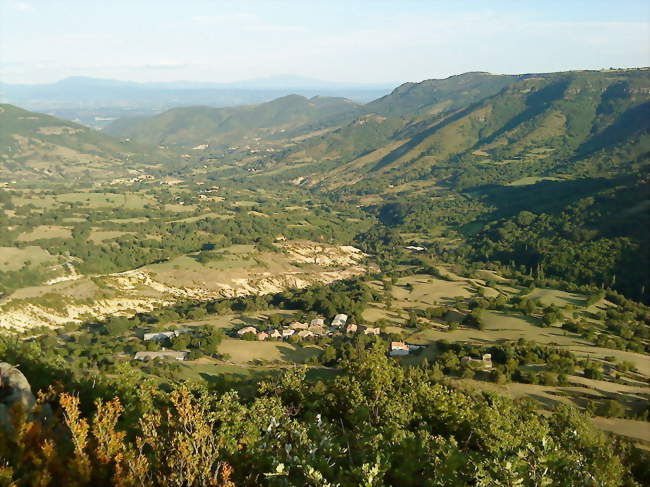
[237, 314, 379, 341]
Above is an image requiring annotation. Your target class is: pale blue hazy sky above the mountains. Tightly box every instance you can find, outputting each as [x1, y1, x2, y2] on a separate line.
[0, 0, 650, 83]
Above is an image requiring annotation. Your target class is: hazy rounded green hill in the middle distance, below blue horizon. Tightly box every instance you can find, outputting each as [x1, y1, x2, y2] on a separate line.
[105, 95, 361, 146]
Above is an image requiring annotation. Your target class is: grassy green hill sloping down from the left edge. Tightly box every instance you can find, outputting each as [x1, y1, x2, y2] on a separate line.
[0, 104, 171, 180]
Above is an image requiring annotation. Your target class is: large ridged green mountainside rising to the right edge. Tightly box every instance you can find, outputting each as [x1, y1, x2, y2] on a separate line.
[260, 69, 650, 193]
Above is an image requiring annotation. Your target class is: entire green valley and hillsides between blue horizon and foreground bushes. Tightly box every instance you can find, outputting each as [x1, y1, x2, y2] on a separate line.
[0, 68, 650, 485]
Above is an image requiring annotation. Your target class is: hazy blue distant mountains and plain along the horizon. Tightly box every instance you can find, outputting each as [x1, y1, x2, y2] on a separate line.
[0, 75, 392, 127]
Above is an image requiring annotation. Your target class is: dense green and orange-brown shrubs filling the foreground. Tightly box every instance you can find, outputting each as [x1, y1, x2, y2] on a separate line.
[0, 348, 639, 487]
